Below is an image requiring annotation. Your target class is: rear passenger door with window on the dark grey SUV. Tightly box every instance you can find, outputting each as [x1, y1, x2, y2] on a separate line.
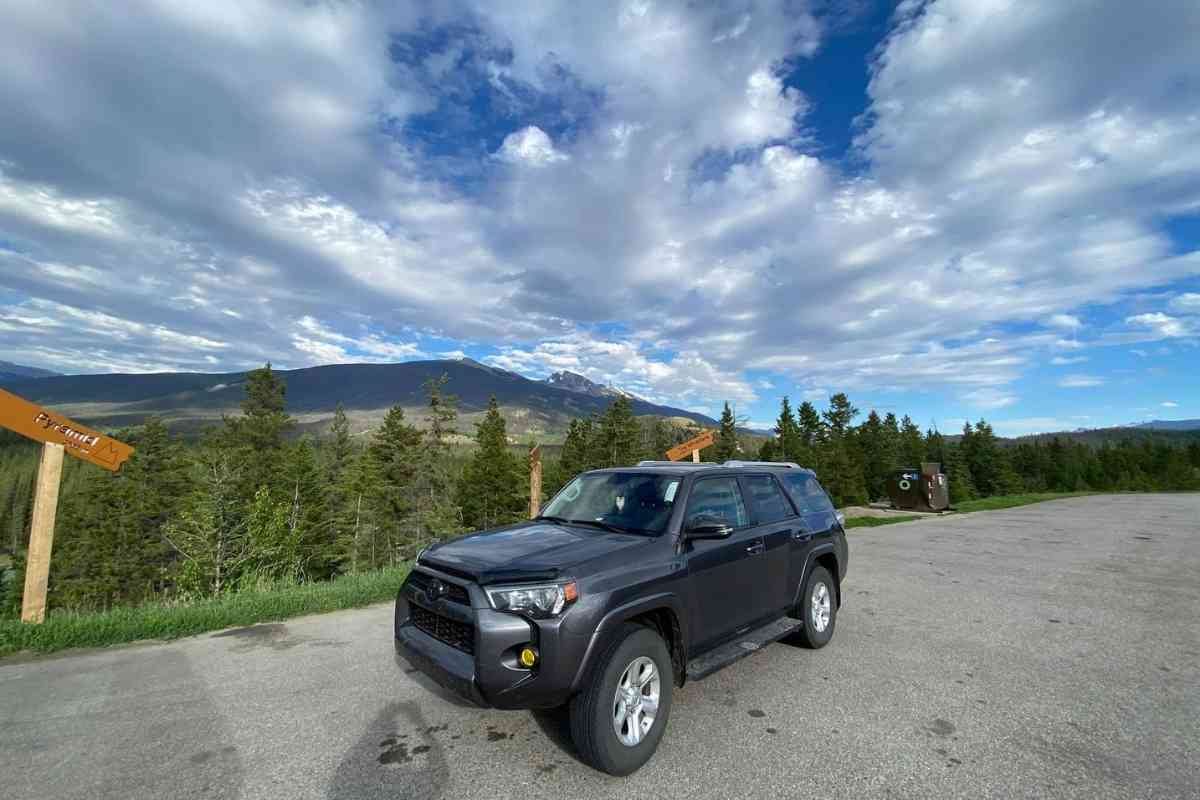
[740, 473, 803, 620]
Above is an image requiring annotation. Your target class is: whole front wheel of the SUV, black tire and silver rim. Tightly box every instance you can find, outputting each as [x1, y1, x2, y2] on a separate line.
[571, 625, 674, 775]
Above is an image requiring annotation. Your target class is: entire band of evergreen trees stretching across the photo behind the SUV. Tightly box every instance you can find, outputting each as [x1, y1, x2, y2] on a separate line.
[0, 365, 1200, 615]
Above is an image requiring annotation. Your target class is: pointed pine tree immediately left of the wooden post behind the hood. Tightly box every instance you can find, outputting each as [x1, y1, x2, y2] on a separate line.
[457, 396, 529, 529]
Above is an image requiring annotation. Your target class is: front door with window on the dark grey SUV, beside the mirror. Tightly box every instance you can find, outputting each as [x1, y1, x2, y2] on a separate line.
[683, 475, 766, 654]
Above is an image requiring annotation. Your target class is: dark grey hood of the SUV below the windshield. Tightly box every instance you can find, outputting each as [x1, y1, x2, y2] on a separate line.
[420, 521, 649, 584]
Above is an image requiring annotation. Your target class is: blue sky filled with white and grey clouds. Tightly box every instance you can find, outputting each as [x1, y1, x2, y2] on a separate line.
[0, 0, 1200, 435]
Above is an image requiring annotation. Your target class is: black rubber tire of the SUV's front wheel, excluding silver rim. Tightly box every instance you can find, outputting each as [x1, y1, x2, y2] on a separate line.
[570, 624, 674, 775]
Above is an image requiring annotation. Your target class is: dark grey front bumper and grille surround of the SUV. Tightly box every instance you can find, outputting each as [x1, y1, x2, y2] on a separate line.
[395, 565, 587, 709]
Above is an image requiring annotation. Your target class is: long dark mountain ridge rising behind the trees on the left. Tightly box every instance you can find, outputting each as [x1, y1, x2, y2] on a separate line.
[0, 359, 715, 439]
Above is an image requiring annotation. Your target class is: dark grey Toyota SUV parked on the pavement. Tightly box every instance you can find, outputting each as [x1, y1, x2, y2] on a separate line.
[395, 462, 847, 775]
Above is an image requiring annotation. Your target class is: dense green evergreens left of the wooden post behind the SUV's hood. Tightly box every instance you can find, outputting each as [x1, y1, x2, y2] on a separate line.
[0, 365, 537, 614]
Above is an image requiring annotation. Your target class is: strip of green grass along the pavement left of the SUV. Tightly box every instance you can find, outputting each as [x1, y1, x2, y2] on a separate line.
[0, 566, 408, 656]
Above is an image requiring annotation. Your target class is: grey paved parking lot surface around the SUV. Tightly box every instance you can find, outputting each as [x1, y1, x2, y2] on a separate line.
[0, 494, 1200, 800]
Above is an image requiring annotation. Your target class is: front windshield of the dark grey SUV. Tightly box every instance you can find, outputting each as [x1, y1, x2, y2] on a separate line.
[541, 473, 679, 534]
